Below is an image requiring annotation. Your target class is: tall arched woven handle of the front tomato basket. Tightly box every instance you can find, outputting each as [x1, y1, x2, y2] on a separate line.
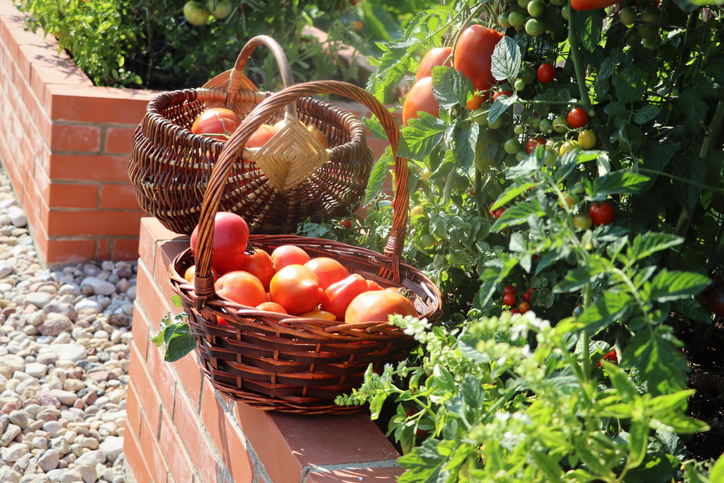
[194, 80, 410, 309]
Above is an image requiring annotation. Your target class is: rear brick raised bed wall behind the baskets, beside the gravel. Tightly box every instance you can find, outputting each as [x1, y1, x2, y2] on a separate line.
[0, 0, 387, 265]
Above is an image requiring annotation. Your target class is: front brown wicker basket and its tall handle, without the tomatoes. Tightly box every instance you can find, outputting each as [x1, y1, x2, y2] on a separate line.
[169, 81, 441, 414]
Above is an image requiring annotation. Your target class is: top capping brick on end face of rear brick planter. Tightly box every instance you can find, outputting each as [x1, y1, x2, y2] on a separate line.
[46, 84, 153, 127]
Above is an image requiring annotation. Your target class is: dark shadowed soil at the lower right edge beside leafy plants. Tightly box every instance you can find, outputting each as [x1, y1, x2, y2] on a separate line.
[678, 318, 724, 461]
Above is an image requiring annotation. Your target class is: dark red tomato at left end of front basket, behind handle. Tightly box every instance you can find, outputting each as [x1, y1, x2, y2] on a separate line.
[191, 211, 249, 275]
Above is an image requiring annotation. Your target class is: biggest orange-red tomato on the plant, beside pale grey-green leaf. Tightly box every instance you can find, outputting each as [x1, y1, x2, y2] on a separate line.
[453, 24, 503, 101]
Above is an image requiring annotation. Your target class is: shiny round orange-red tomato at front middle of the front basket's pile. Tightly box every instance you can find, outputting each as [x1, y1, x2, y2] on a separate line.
[269, 265, 324, 315]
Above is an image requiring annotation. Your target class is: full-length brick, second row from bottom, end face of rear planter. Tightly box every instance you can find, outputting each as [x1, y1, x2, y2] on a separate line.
[48, 210, 144, 237]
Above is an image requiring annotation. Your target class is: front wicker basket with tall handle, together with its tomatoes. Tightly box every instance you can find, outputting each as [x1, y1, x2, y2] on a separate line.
[170, 81, 442, 414]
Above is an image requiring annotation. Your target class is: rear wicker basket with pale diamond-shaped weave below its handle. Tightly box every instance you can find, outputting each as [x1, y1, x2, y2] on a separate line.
[128, 36, 373, 234]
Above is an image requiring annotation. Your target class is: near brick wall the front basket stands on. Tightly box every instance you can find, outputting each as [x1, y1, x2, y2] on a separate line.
[124, 218, 402, 483]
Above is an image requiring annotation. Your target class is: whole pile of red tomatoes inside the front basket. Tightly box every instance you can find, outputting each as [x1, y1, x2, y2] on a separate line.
[184, 212, 418, 325]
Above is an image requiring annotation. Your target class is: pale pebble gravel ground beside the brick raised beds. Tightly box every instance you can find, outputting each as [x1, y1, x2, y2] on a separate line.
[0, 170, 137, 483]
